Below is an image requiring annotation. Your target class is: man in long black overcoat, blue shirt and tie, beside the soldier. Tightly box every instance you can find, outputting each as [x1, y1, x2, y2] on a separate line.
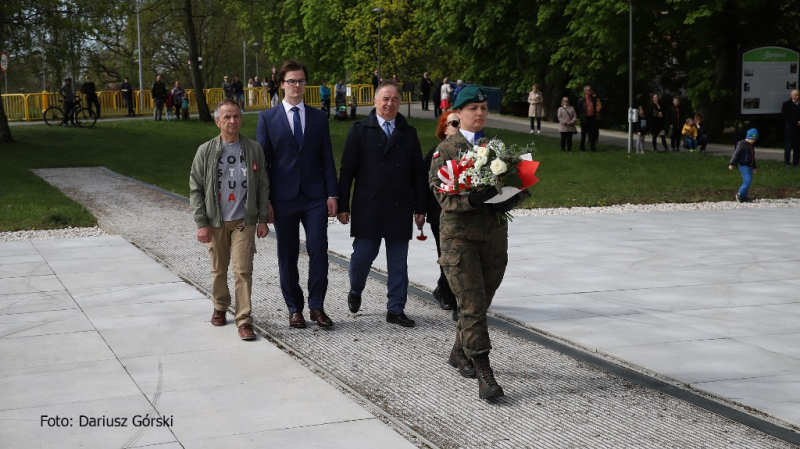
[338, 83, 427, 327]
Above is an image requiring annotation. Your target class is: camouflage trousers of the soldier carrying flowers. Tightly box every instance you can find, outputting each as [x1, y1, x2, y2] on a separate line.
[439, 235, 508, 358]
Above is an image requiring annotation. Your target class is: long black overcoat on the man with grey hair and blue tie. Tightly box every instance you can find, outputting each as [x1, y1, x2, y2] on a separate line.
[339, 109, 427, 240]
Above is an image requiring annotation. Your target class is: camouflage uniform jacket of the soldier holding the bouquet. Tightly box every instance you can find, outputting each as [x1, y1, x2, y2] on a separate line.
[428, 133, 531, 241]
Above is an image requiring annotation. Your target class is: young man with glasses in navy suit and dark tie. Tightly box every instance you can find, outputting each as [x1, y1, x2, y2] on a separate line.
[256, 59, 338, 328]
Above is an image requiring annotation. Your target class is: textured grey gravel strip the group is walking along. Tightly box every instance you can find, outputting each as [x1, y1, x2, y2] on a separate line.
[28, 169, 793, 448]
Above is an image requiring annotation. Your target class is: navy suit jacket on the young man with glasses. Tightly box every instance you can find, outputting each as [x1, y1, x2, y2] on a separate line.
[256, 102, 338, 201]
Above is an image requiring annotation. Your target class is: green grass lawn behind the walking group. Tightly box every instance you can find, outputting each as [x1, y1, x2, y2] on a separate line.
[0, 114, 800, 231]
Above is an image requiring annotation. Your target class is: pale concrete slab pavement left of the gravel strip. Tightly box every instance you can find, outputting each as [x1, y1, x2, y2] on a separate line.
[0, 236, 416, 449]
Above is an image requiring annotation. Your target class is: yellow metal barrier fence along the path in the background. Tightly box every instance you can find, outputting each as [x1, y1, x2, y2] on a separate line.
[2, 84, 411, 121]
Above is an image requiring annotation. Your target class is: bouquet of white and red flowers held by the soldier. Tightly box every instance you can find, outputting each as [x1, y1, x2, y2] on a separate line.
[438, 138, 539, 214]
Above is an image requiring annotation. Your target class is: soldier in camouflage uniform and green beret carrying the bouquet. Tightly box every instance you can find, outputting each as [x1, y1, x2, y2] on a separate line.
[429, 86, 530, 399]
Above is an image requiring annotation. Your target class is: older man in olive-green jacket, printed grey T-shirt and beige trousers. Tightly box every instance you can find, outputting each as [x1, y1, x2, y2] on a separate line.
[189, 100, 269, 340]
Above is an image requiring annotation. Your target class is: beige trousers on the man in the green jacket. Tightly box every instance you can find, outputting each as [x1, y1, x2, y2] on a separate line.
[206, 220, 256, 327]
